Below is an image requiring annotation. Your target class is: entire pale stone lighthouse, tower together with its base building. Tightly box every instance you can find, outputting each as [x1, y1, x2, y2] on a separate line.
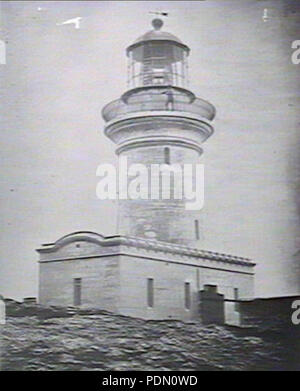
[37, 19, 254, 324]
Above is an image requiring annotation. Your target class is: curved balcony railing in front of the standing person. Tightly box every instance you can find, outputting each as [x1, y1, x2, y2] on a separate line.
[102, 93, 215, 122]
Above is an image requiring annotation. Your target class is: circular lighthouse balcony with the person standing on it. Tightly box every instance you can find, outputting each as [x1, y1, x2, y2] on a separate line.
[102, 87, 216, 122]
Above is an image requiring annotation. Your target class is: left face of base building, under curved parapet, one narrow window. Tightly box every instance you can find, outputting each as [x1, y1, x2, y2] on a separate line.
[39, 241, 120, 312]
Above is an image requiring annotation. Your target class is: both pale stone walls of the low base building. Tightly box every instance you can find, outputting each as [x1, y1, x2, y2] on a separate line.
[39, 240, 253, 323]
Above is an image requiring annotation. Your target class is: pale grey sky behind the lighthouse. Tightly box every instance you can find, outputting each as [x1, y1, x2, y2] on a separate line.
[0, 0, 300, 299]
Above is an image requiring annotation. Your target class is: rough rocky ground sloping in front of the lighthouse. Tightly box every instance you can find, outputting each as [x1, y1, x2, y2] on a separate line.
[0, 307, 300, 371]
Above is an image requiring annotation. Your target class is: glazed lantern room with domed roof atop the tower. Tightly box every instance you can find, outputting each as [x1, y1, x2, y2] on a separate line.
[127, 19, 190, 88]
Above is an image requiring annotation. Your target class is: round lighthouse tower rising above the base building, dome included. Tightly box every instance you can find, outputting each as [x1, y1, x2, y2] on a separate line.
[102, 19, 215, 247]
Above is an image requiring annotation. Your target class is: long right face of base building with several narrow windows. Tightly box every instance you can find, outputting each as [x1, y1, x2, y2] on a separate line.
[119, 255, 253, 321]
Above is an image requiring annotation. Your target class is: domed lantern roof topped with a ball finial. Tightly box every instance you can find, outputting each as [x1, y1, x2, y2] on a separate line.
[127, 19, 189, 52]
